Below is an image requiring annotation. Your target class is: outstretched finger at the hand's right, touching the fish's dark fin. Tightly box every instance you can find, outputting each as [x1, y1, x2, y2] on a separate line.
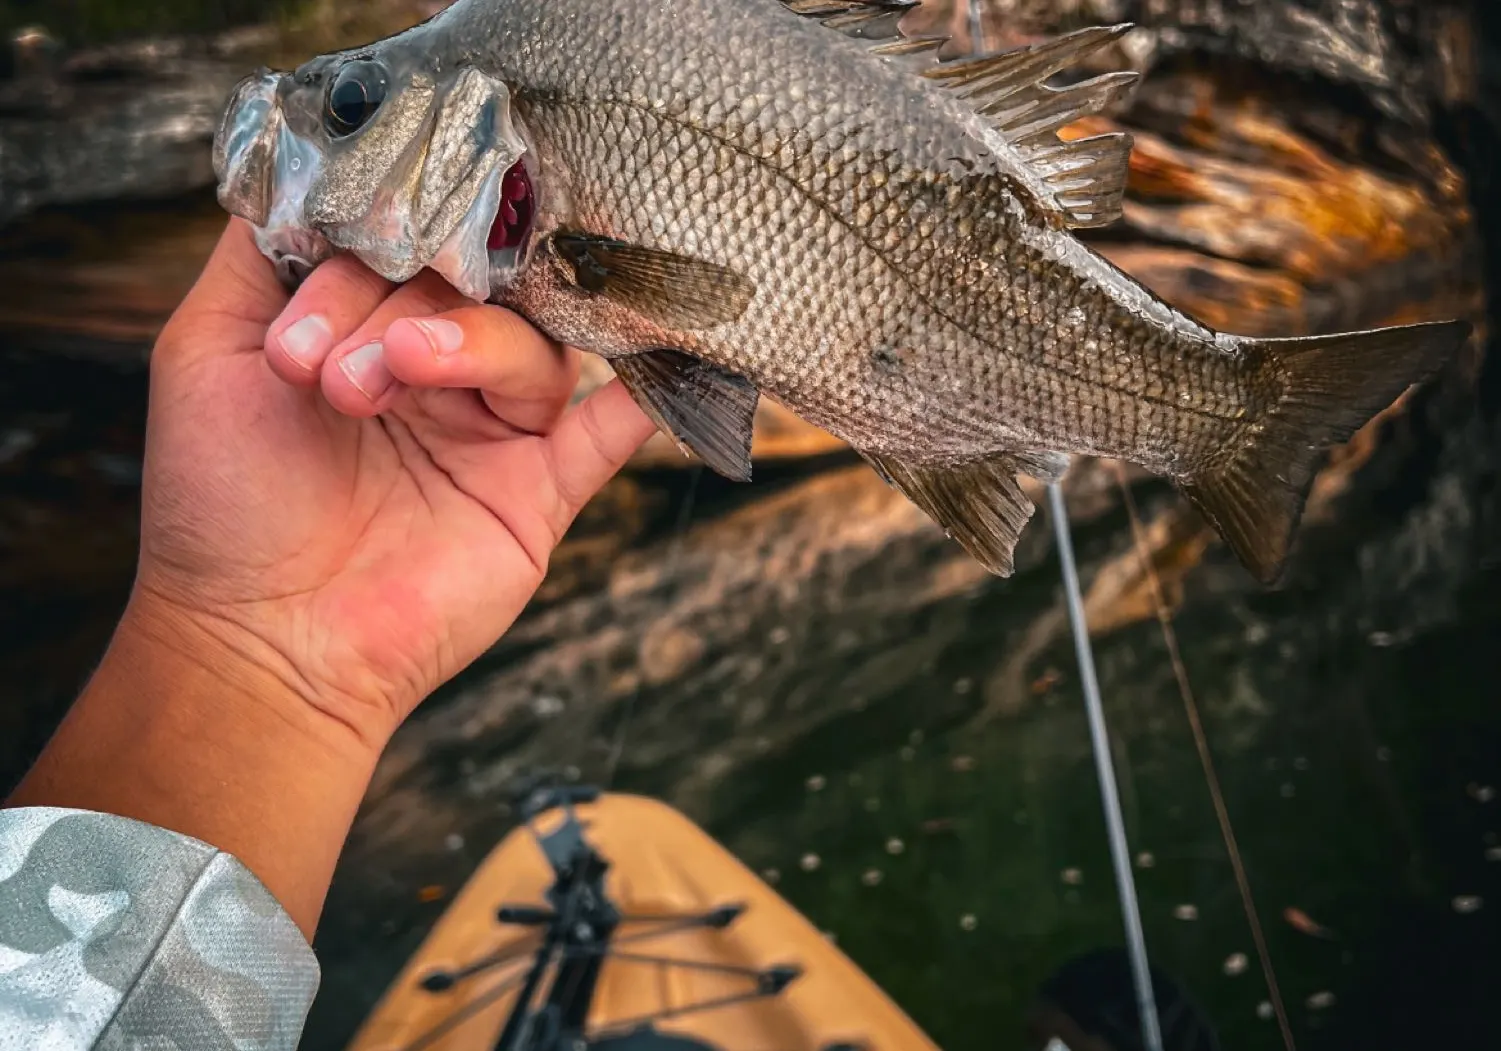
[545, 380, 656, 538]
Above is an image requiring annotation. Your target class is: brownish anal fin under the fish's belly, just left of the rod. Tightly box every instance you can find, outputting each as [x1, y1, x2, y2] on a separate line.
[860, 452, 1036, 577]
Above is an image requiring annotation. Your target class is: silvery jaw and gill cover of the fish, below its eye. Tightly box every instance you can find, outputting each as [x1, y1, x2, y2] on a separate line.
[215, 60, 527, 300]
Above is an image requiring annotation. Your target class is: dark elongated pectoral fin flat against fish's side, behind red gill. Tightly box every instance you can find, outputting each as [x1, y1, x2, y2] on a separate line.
[552, 233, 755, 332]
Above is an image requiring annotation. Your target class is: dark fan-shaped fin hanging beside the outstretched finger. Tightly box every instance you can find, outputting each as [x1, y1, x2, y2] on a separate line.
[611, 350, 761, 482]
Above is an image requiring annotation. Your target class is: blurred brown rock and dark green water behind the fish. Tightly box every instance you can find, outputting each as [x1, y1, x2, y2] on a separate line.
[0, 0, 1501, 1051]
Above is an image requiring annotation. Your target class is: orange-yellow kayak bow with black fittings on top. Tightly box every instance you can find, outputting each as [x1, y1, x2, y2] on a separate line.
[348, 785, 938, 1051]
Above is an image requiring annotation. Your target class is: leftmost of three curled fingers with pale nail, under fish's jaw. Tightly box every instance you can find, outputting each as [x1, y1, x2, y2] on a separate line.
[266, 255, 395, 387]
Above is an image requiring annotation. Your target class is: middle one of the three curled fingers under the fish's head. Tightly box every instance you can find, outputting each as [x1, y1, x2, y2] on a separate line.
[318, 270, 473, 417]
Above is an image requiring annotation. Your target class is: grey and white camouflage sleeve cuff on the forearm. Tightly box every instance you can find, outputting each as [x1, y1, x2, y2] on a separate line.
[0, 809, 318, 1051]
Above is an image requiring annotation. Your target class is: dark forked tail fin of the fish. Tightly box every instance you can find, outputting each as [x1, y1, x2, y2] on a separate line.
[1183, 321, 1471, 584]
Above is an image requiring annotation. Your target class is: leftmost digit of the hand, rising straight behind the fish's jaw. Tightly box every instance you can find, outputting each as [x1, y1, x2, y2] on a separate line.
[159, 216, 288, 361]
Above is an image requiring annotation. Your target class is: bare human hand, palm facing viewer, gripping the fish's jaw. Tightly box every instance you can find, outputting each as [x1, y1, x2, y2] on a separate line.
[128, 219, 653, 748]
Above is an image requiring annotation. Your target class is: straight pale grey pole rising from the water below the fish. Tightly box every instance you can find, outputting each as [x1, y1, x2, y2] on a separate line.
[1048, 482, 1162, 1051]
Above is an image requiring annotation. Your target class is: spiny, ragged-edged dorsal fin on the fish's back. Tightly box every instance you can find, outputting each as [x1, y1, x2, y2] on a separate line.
[781, 0, 1139, 230]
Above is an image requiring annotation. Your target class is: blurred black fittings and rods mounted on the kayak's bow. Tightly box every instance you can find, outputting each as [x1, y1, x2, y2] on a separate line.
[402, 775, 822, 1051]
